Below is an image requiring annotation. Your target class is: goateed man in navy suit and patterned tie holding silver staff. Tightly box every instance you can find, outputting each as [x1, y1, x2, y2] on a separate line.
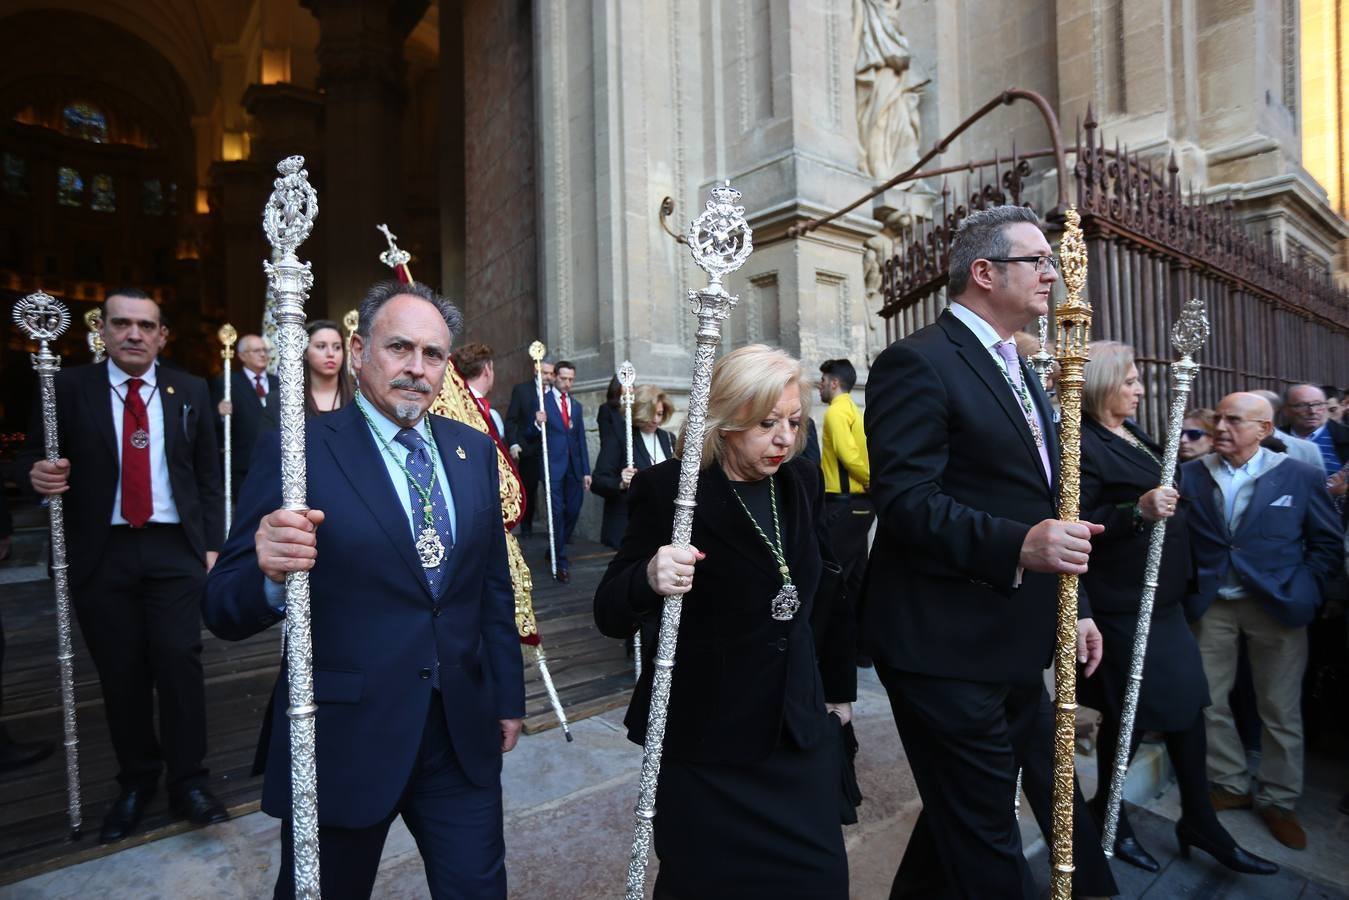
[205, 282, 525, 900]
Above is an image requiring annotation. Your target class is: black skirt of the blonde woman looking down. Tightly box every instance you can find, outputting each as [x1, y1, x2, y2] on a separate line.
[654, 739, 849, 900]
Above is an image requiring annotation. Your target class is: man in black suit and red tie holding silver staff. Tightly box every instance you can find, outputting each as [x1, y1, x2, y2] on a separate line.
[22, 287, 229, 842]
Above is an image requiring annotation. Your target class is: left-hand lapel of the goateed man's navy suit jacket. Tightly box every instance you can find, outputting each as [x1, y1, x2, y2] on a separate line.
[322, 403, 431, 596]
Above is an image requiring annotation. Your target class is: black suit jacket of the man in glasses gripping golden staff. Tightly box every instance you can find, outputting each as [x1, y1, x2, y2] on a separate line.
[862, 312, 1090, 684]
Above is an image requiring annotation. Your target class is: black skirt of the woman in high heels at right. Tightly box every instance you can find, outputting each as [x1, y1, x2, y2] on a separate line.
[1078, 603, 1210, 735]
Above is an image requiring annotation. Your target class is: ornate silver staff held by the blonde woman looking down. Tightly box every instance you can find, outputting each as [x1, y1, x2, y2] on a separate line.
[627, 182, 754, 900]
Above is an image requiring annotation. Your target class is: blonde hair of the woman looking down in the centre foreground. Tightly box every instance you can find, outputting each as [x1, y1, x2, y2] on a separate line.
[675, 344, 811, 468]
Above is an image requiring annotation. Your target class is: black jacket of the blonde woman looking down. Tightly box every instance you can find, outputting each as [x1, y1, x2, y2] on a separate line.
[595, 459, 857, 764]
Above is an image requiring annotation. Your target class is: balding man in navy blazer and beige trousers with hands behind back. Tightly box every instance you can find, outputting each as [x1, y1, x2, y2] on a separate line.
[1180, 393, 1344, 850]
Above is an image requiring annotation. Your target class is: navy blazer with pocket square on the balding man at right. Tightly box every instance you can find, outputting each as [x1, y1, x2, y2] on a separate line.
[1179, 451, 1344, 627]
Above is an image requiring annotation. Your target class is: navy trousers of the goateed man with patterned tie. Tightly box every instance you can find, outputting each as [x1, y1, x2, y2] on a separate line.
[272, 691, 506, 900]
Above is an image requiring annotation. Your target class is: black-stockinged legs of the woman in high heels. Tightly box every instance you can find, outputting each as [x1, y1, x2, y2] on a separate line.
[1091, 711, 1236, 847]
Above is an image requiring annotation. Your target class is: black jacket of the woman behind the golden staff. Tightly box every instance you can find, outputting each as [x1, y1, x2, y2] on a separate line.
[1081, 416, 1191, 615]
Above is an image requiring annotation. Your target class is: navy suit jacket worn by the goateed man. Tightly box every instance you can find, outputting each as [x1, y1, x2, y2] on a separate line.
[202, 403, 525, 828]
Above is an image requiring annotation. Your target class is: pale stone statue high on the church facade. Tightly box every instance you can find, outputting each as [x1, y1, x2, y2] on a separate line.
[853, 0, 929, 182]
